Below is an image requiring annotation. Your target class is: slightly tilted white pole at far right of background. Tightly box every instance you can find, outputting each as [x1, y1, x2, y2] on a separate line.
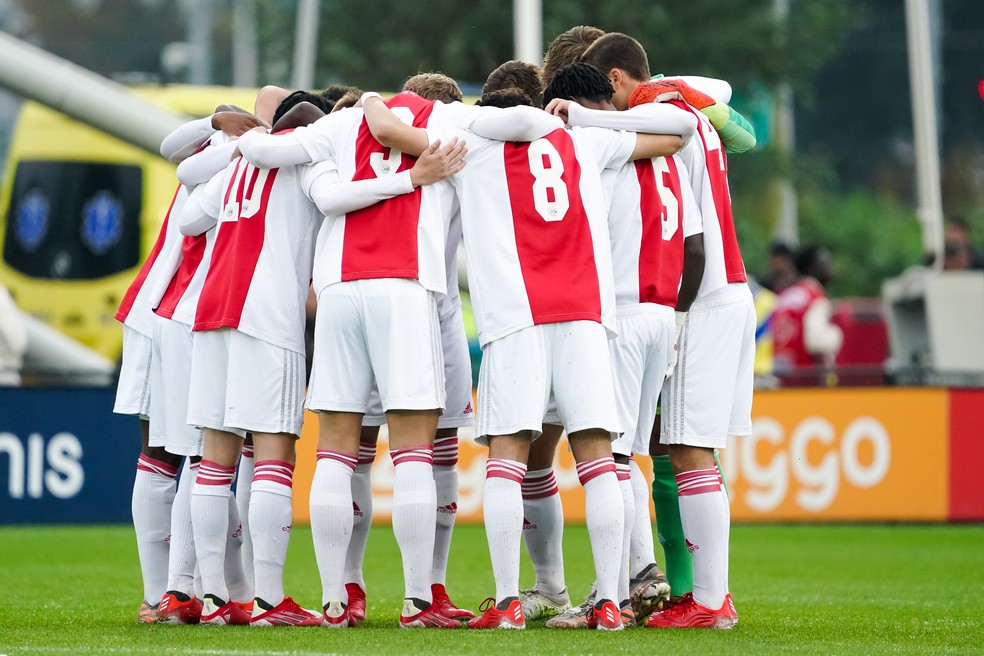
[905, 0, 943, 268]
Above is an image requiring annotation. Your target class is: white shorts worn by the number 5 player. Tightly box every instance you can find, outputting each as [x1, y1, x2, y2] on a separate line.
[609, 303, 676, 456]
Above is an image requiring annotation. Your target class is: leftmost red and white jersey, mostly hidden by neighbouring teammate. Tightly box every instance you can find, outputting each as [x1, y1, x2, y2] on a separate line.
[116, 185, 188, 337]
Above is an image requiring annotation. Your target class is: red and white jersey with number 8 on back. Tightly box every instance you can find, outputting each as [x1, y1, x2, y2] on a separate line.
[428, 128, 635, 345]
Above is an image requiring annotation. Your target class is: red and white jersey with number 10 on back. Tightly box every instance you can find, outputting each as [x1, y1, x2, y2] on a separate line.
[185, 157, 327, 353]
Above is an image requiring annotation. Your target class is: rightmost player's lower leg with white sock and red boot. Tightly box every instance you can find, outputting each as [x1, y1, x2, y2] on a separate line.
[646, 444, 738, 629]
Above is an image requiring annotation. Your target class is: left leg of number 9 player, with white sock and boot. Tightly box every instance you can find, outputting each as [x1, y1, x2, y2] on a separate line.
[311, 411, 362, 627]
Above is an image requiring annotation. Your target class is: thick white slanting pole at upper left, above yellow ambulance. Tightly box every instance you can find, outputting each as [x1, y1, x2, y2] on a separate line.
[0, 32, 187, 155]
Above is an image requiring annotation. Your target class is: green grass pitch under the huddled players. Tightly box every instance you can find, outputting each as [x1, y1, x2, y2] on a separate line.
[0, 525, 984, 656]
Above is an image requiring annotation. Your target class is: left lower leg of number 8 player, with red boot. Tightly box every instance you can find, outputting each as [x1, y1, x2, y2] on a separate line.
[468, 431, 533, 629]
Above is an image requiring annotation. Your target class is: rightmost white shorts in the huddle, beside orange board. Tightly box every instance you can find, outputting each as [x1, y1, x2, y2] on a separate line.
[660, 283, 755, 449]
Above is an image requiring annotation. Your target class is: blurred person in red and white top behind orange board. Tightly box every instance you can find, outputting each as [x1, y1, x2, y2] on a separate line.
[772, 244, 844, 387]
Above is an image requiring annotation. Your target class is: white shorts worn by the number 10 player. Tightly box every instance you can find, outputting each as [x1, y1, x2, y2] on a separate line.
[188, 328, 304, 436]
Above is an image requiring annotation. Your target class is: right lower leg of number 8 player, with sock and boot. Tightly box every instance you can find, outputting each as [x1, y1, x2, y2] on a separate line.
[569, 429, 625, 630]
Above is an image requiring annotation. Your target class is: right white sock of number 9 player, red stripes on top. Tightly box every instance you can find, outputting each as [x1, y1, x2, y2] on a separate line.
[390, 445, 437, 603]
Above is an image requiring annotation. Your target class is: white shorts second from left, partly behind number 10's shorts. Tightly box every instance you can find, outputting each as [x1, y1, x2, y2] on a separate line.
[150, 317, 202, 456]
